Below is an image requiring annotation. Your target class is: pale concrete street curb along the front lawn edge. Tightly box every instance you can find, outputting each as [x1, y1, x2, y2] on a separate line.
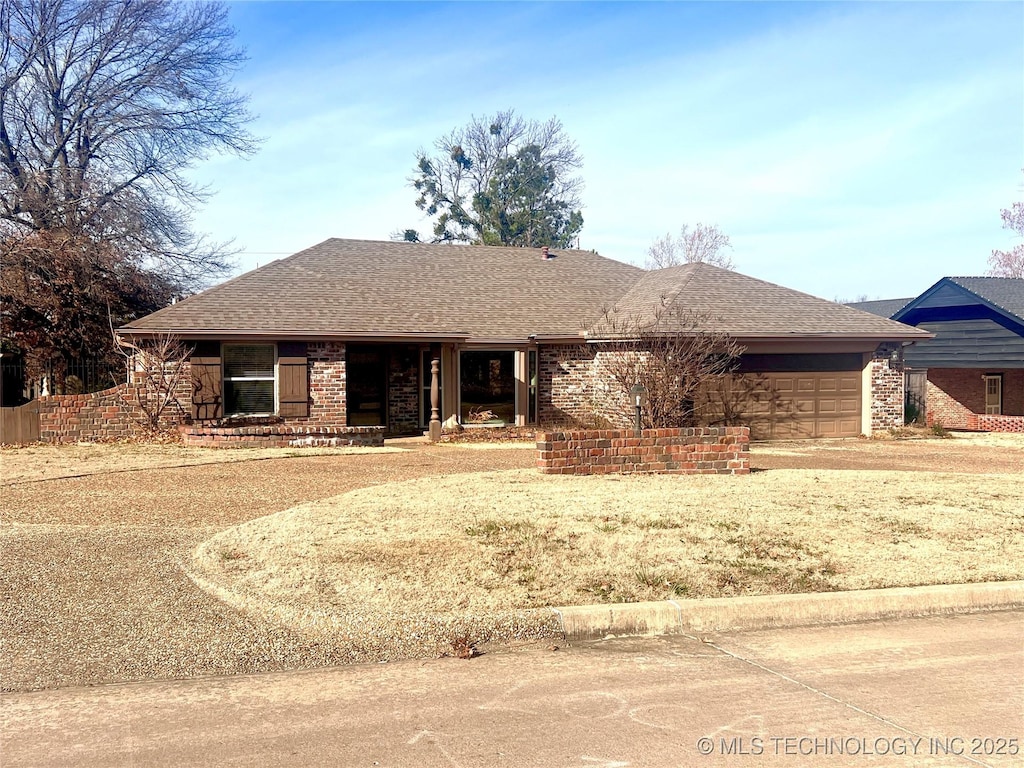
[552, 582, 1024, 640]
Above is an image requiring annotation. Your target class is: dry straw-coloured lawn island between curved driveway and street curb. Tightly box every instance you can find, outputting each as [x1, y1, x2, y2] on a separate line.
[191, 460, 1024, 631]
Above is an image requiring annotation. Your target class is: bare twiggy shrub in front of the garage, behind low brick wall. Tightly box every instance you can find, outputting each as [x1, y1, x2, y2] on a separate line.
[592, 307, 743, 428]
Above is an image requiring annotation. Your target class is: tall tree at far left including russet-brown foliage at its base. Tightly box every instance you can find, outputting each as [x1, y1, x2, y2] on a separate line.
[0, 0, 254, 382]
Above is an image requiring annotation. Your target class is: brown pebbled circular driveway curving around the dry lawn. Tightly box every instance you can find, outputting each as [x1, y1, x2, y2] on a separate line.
[0, 438, 1024, 690]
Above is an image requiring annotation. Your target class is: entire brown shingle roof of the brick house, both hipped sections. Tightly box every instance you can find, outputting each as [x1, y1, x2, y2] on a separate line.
[121, 240, 928, 340]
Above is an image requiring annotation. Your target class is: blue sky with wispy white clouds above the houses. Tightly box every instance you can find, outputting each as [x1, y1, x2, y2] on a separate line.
[186, 2, 1024, 299]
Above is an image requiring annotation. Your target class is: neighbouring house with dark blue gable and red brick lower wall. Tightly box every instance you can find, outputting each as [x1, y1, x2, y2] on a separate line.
[851, 278, 1024, 432]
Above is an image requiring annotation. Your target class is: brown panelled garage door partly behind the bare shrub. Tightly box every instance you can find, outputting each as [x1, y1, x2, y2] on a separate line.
[740, 371, 861, 439]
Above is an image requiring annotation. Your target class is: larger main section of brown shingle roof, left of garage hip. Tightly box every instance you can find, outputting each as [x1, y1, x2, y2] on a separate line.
[125, 240, 643, 339]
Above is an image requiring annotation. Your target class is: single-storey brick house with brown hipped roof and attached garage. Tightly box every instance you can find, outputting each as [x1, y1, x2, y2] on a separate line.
[119, 240, 930, 437]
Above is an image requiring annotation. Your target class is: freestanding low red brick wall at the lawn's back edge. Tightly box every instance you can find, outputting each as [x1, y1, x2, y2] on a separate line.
[537, 427, 751, 475]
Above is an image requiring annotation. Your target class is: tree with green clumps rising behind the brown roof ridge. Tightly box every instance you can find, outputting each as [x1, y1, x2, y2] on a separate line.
[407, 110, 583, 248]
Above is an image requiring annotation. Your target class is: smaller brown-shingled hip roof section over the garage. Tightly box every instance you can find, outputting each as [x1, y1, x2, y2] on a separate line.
[588, 263, 928, 339]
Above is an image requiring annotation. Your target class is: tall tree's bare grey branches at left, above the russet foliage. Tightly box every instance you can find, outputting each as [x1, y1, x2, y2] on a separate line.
[0, 0, 254, 285]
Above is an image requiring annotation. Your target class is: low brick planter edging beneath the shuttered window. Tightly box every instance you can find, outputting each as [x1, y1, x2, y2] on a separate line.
[179, 424, 384, 447]
